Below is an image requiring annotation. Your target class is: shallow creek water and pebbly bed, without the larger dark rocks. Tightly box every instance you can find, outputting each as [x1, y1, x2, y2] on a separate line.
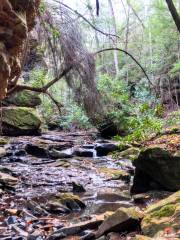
[0, 132, 139, 240]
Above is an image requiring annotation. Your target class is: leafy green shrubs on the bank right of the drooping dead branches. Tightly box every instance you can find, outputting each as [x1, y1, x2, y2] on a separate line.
[98, 74, 163, 143]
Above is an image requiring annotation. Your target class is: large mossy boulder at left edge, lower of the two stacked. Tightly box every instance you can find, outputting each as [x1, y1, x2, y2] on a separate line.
[2, 107, 41, 136]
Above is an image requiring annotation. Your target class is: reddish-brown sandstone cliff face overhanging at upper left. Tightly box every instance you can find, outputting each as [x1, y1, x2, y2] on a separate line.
[0, 0, 40, 100]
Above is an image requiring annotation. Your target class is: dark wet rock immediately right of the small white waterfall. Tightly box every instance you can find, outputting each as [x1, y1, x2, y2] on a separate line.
[95, 143, 118, 157]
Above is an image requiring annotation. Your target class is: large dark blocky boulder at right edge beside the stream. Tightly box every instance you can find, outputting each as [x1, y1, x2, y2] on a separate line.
[131, 147, 180, 193]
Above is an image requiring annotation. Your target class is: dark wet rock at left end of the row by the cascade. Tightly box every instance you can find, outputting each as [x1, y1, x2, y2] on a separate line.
[25, 143, 48, 158]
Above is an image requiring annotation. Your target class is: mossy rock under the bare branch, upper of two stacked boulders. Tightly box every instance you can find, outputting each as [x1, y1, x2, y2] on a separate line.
[5, 90, 41, 107]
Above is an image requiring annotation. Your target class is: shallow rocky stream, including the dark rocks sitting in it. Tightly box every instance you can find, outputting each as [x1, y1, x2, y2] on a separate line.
[0, 132, 141, 240]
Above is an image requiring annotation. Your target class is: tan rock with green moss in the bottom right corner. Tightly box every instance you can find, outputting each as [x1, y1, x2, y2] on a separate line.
[141, 191, 180, 239]
